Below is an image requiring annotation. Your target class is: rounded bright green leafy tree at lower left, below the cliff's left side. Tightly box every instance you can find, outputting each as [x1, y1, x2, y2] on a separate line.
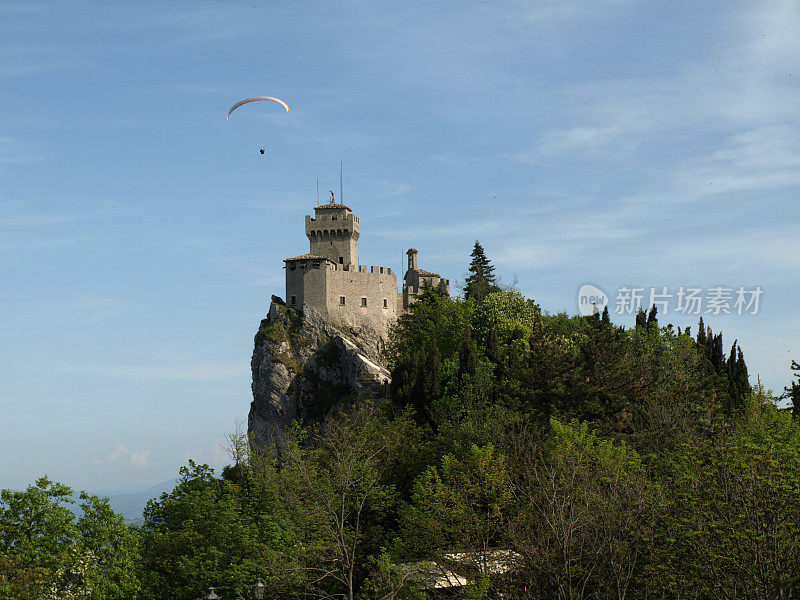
[137, 460, 278, 599]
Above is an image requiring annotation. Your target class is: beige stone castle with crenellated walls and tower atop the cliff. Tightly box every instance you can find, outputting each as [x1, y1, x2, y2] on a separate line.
[283, 194, 450, 339]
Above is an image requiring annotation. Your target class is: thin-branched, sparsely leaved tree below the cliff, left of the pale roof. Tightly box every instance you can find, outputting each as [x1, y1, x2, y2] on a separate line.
[280, 404, 408, 600]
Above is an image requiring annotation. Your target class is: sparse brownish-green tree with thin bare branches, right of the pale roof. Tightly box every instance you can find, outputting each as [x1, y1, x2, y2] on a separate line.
[510, 419, 657, 599]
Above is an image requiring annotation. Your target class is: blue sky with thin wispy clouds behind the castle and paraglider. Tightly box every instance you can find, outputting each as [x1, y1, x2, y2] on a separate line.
[0, 0, 800, 489]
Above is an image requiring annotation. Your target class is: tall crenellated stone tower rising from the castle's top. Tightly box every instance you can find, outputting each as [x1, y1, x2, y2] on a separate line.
[306, 194, 361, 271]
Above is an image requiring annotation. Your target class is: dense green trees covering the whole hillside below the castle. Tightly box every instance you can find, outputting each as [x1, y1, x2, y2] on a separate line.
[0, 243, 800, 600]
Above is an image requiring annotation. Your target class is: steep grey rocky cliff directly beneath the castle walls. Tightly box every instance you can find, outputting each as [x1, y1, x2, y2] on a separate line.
[248, 296, 390, 450]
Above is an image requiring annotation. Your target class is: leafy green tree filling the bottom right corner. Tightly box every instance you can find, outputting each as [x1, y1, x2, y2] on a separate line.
[650, 389, 800, 600]
